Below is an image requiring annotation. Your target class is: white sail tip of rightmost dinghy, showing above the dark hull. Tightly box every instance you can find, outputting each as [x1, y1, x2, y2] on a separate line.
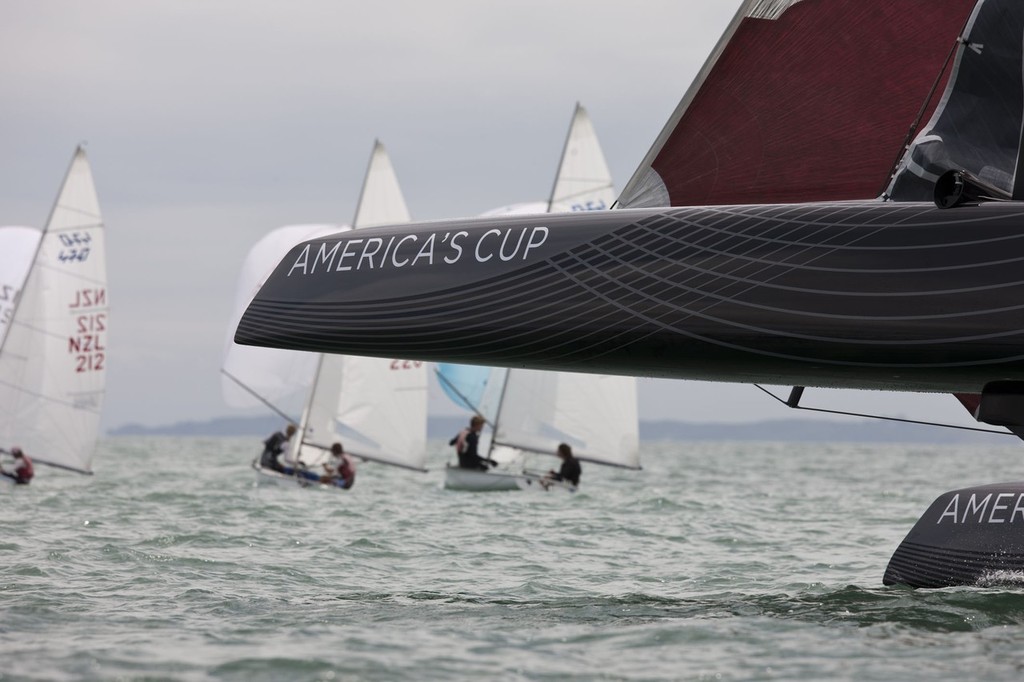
[547, 102, 615, 213]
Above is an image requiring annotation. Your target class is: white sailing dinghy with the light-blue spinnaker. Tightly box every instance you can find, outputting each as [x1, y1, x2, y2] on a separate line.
[435, 102, 640, 491]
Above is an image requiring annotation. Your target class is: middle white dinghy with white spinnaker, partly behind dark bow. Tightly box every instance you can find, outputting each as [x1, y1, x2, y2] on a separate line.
[222, 140, 427, 485]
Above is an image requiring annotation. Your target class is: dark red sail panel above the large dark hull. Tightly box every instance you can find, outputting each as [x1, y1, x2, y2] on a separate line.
[622, 0, 975, 207]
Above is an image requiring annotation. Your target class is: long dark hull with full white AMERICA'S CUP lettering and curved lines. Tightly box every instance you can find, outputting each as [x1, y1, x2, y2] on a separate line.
[236, 202, 1024, 392]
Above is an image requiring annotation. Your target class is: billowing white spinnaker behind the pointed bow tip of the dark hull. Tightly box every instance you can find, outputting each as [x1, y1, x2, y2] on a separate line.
[220, 224, 351, 409]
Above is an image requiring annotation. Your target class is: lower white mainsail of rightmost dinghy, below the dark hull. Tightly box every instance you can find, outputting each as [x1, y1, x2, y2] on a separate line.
[495, 370, 640, 469]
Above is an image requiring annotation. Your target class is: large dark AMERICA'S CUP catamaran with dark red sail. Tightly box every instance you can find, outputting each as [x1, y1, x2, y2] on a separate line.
[236, 0, 1024, 587]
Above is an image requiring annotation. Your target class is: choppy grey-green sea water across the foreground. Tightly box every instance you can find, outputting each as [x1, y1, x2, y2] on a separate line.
[6, 437, 1024, 682]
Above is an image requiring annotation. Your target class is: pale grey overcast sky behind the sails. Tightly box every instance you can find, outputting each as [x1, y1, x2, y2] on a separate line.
[0, 0, 987, 428]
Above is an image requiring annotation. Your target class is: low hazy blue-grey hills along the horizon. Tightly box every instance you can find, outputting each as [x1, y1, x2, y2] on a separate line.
[108, 417, 1014, 444]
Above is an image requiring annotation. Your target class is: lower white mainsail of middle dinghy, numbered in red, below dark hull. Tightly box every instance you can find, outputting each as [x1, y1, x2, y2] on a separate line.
[296, 355, 427, 469]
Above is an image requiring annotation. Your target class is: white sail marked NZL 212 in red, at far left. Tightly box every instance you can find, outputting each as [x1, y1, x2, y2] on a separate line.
[0, 148, 110, 473]
